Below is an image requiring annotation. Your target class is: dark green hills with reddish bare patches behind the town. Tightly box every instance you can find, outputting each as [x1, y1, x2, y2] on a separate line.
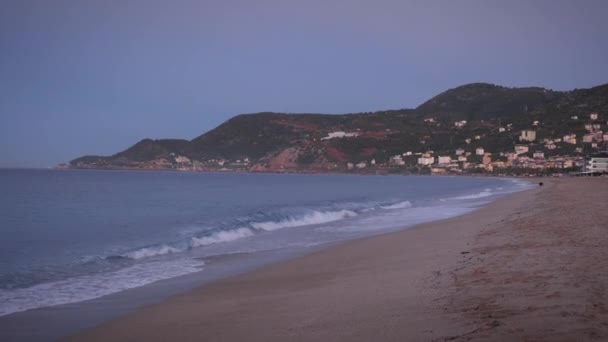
[67, 83, 608, 172]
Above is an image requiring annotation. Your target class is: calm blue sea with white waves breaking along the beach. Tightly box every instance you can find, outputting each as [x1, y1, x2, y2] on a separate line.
[0, 169, 531, 316]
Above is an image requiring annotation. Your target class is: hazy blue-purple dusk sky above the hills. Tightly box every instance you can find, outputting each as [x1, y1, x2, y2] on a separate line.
[0, 0, 608, 167]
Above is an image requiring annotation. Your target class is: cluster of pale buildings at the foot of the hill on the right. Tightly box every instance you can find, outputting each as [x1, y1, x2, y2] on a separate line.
[376, 113, 608, 175]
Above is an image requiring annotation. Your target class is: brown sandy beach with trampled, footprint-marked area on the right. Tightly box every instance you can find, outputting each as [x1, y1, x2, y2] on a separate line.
[68, 178, 608, 341]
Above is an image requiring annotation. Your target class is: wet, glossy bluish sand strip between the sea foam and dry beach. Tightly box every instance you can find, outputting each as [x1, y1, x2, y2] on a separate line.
[0, 175, 528, 341]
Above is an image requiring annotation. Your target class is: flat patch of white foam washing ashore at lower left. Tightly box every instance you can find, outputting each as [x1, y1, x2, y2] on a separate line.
[0, 259, 204, 316]
